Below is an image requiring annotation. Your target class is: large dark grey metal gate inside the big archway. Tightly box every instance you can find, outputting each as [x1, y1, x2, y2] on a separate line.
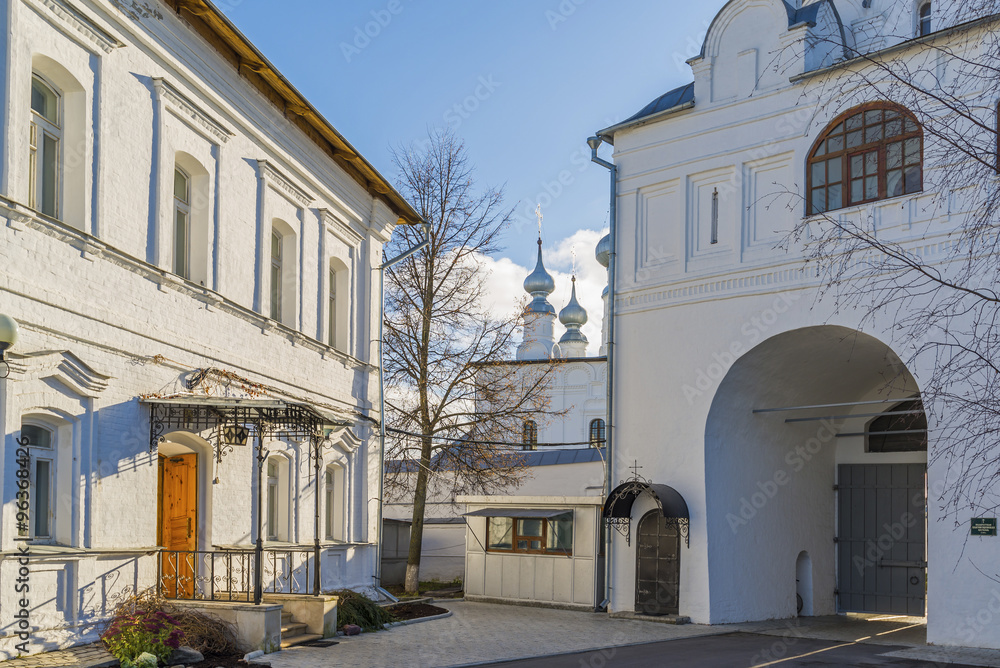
[837, 464, 927, 616]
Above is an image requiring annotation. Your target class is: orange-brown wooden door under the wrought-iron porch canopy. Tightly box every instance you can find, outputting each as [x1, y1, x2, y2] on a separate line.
[157, 454, 198, 598]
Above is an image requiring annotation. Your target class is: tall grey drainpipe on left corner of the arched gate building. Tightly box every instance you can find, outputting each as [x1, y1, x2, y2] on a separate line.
[587, 137, 618, 608]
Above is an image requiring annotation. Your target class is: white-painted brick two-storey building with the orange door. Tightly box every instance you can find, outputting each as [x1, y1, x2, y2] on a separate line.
[0, 0, 418, 659]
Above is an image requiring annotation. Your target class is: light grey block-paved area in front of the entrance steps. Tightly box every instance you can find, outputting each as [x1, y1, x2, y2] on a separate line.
[266, 601, 726, 668]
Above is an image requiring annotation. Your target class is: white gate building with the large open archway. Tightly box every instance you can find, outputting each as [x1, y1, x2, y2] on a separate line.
[599, 0, 1000, 648]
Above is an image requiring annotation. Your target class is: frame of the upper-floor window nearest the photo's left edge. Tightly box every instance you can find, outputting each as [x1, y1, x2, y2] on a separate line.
[28, 72, 66, 220]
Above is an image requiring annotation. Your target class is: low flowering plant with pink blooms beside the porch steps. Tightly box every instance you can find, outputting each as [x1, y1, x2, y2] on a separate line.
[101, 610, 184, 667]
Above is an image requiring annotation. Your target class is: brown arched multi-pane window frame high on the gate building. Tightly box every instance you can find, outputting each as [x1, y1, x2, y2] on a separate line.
[805, 101, 925, 216]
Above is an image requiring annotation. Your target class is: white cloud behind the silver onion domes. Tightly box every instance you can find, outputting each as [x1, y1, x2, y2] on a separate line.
[482, 229, 608, 356]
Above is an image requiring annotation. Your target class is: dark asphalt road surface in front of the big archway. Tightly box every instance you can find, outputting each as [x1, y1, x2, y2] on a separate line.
[491, 633, 973, 668]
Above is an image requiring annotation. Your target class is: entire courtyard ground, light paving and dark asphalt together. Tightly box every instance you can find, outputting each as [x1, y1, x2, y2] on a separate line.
[267, 601, 1000, 668]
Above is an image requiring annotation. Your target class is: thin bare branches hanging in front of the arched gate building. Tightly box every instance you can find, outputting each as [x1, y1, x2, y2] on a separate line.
[774, 0, 1000, 522]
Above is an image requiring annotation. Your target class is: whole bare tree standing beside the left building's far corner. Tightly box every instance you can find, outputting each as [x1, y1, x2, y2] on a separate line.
[384, 133, 551, 592]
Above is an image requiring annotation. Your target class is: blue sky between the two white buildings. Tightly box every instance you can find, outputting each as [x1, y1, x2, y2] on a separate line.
[217, 0, 724, 340]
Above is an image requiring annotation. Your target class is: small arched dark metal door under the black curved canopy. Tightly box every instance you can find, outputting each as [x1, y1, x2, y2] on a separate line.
[635, 510, 681, 615]
